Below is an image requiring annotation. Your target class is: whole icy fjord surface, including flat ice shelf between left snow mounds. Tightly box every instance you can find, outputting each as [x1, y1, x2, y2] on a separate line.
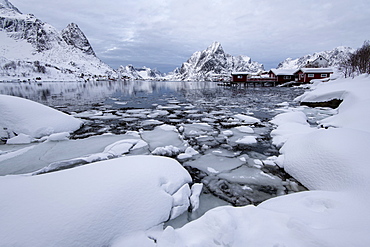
[0, 81, 306, 226]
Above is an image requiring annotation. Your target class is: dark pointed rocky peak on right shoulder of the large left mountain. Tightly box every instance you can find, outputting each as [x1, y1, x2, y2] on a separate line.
[61, 23, 95, 56]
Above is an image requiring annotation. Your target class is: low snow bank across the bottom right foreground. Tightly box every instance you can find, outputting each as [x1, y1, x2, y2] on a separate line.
[156, 191, 370, 247]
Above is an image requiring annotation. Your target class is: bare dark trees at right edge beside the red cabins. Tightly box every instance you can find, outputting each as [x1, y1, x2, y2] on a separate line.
[341, 40, 370, 77]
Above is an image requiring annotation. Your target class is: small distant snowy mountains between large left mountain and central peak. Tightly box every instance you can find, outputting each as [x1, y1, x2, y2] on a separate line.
[117, 64, 163, 80]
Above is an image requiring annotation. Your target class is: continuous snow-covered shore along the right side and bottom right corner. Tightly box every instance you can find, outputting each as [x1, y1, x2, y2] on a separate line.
[144, 75, 370, 247]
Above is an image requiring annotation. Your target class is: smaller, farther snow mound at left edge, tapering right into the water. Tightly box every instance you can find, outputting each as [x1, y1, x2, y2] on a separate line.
[0, 95, 83, 138]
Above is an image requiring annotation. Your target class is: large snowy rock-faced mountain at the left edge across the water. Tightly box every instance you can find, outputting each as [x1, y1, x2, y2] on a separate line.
[0, 0, 115, 80]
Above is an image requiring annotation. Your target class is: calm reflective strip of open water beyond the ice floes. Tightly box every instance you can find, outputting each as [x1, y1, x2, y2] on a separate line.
[0, 81, 302, 118]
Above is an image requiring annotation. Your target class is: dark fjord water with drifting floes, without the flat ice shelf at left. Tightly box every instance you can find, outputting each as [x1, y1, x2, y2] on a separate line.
[0, 81, 303, 226]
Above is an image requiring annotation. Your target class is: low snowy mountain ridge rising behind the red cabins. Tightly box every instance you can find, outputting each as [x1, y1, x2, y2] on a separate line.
[277, 46, 355, 69]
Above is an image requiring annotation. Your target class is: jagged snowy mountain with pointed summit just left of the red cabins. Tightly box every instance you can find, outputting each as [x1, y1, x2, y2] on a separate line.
[171, 42, 264, 81]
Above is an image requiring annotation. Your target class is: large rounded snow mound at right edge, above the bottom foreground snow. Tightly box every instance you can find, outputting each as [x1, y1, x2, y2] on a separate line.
[280, 126, 370, 191]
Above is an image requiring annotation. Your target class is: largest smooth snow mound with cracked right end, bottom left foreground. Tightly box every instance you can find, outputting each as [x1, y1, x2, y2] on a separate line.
[0, 156, 195, 247]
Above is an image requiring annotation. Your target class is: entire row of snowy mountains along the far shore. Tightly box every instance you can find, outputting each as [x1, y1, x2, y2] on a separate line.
[0, 0, 354, 81]
